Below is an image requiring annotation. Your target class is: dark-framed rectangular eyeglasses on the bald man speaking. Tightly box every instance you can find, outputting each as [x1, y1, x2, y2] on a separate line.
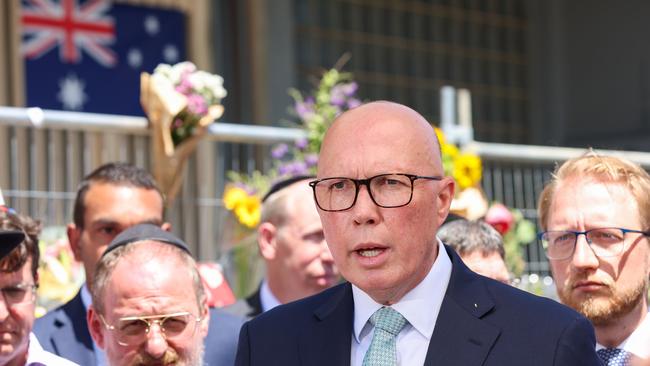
[309, 173, 442, 212]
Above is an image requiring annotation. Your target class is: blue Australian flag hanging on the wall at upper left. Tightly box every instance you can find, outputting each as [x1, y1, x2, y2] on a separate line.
[21, 0, 186, 115]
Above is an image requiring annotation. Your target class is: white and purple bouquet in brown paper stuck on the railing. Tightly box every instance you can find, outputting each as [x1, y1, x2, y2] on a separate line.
[140, 62, 226, 202]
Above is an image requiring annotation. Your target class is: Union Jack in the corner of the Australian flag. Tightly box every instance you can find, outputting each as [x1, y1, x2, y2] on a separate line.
[21, 0, 117, 67]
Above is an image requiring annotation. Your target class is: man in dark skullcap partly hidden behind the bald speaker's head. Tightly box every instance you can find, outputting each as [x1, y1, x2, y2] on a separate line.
[226, 176, 339, 318]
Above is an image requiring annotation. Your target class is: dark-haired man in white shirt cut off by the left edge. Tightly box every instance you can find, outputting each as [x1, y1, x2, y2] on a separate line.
[0, 210, 74, 366]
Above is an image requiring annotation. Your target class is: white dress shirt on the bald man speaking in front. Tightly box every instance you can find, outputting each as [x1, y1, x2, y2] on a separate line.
[350, 240, 451, 366]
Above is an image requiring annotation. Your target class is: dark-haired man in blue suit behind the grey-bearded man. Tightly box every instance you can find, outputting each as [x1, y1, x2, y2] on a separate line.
[34, 163, 241, 366]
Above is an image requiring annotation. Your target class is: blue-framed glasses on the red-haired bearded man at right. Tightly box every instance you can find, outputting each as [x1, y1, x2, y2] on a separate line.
[538, 227, 650, 260]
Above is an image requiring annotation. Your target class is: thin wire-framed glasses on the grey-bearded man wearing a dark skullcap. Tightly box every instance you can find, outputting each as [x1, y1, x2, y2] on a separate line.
[99, 311, 203, 346]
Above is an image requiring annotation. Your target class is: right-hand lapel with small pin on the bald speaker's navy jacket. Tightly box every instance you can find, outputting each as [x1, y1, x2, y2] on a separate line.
[424, 246, 500, 366]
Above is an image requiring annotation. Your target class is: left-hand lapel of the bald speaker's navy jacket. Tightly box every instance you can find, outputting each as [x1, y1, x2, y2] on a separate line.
[298, 283, 354, 366]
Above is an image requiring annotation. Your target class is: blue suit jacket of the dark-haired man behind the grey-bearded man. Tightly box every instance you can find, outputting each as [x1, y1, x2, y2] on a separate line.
[33, 292, 244, 366]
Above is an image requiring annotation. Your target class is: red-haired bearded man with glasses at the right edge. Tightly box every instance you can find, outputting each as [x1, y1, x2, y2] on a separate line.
[539, 151, 650, 365]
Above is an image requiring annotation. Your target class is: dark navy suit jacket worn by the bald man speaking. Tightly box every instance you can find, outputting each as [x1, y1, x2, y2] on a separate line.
[236, 247, 600, 366]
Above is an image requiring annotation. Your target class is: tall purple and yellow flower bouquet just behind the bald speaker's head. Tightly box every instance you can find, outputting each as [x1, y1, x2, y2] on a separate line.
[223, 68, 361, 296]
